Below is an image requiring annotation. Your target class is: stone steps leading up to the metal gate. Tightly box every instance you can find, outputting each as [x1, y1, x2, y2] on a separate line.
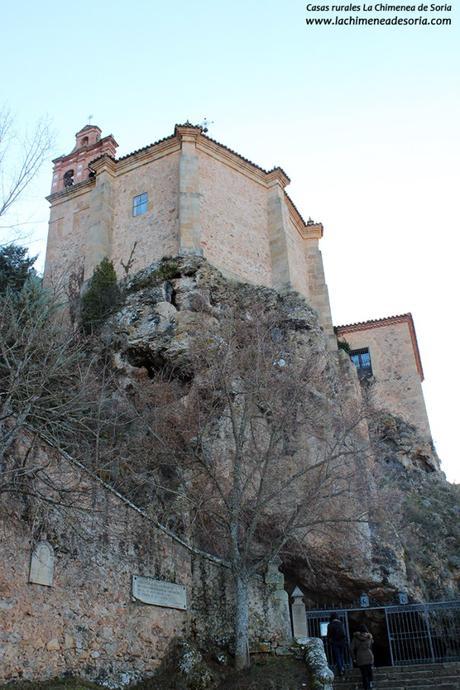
[334, 662, 460, 690]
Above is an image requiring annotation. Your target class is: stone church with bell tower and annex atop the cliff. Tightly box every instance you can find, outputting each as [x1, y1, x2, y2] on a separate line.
[45, 122, 430, 438]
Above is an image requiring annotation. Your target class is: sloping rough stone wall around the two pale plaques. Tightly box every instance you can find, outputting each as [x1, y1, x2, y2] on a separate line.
[0, 440, 290, 687]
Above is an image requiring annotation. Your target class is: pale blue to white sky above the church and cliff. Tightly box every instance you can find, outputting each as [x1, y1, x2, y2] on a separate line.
[0, 0, 460, 481]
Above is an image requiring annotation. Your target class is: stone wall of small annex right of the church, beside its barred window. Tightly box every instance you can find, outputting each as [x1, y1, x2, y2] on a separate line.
[337, 314, 431, 439]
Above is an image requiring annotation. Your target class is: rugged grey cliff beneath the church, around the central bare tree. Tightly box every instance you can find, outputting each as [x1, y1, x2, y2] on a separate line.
[102, 257, 459, 604]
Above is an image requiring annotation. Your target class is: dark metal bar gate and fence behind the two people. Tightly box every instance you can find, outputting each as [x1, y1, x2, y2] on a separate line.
[307, 601, 460, 668]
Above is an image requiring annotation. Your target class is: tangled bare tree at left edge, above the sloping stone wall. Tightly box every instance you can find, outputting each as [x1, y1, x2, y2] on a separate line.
[0, 278, 117, 498]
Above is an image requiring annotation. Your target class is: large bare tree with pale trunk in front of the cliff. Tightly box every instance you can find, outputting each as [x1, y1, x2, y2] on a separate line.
[123, 305, 374, 668]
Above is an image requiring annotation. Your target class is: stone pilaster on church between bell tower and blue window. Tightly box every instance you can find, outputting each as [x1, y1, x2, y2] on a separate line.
[84, 156, 115, 281]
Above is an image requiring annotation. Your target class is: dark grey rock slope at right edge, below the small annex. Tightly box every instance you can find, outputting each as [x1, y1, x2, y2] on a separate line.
[369, 413, 460, 601]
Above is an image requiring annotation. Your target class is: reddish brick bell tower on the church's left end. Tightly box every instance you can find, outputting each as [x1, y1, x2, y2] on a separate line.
[51, 124, 118, 194]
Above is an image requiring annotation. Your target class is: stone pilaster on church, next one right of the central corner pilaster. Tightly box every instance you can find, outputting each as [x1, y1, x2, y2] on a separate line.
[267, 173, 292, 292]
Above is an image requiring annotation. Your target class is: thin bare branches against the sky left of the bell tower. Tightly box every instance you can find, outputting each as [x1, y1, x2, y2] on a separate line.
[0, 108, 53, 222]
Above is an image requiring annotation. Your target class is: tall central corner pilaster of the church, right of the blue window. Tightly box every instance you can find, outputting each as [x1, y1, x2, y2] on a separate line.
[176, 126, 203, 256]
